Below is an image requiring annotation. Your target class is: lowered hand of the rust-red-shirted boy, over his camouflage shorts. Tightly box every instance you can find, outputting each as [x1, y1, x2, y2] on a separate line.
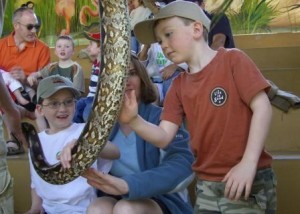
[222, 161, 257, 200]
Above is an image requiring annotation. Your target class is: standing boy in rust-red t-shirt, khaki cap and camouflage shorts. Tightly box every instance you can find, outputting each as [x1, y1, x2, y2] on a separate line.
[120, 1, 276, 213]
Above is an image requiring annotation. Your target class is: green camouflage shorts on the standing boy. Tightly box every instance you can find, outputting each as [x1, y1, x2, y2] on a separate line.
[194, 168, 277, 214]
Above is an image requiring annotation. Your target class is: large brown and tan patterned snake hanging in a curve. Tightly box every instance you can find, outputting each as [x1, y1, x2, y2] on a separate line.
[22, 0, 130, 184]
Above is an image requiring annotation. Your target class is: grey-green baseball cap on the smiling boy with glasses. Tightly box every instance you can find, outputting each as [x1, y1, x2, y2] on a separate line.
[36, 75, 80, 103]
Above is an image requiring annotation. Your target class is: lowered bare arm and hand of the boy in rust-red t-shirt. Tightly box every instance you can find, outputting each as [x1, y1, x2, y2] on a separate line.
[223, 91, 272, 200]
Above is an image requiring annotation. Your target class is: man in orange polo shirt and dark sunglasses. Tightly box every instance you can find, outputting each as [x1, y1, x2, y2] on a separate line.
[0, 7, 50, 155]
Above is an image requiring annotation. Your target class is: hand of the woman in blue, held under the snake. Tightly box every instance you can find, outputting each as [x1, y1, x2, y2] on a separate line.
[82, 168, 129, 195]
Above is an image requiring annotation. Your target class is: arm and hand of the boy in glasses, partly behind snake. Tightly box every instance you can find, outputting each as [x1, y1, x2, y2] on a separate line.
[57, 140, 120, 168]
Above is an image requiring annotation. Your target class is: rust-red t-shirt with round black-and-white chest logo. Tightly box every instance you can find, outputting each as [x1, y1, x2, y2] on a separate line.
[162, 48, 272, 181]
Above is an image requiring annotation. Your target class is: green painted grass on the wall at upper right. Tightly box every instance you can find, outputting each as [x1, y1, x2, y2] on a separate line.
[226, 0, 279, 34]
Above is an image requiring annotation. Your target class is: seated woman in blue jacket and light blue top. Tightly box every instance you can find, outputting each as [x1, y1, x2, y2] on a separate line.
[84, 55, 194, 214]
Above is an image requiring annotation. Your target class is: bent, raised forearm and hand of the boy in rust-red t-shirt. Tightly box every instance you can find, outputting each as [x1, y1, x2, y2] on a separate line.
[119, 91, 179, 148]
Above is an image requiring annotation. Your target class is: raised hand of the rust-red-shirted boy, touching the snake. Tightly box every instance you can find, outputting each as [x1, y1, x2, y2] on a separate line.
[119, 90, 138, 123]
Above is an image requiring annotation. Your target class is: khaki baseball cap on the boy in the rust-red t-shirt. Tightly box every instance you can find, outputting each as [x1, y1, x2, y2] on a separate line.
[134, 1, 210, 44]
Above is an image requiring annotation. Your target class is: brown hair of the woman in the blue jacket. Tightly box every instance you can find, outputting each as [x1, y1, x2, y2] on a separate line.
[130, 53, 157, 104]
